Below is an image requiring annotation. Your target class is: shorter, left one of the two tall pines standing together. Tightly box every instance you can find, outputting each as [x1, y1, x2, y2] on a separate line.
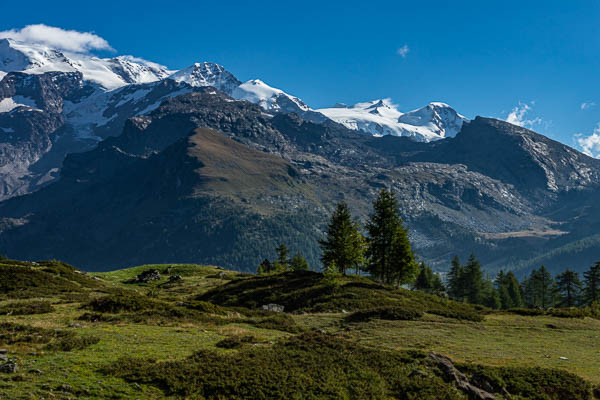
[319, 202, 365, 275]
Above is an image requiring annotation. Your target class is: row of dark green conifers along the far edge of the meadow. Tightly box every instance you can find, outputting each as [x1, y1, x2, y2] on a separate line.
[258, 189, 600, 309]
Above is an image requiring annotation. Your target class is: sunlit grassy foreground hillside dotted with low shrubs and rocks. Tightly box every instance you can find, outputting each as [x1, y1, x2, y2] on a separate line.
[0, 260, 600, 399]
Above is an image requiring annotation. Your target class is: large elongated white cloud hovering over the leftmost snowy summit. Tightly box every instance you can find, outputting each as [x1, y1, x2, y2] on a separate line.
[0, 24, 114, 53]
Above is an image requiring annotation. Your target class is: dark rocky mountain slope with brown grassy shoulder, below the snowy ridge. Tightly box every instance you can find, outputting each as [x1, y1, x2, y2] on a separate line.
[0, 88, 600, 270]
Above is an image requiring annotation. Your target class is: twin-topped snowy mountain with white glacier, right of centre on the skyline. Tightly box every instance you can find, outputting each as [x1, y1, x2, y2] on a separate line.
[316, 99, 468, 142]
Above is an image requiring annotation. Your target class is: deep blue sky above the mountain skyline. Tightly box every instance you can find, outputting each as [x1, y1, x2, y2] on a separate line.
[0, 0, 600, 154]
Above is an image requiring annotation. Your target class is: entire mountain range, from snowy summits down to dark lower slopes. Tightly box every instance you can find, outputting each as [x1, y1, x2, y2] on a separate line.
[0, 39, 600, 271]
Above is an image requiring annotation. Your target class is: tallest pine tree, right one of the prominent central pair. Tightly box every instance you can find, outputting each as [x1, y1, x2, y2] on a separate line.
[367, 189, 417, 285]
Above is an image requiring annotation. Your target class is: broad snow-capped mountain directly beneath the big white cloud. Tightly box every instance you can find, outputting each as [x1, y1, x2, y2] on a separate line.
[0, 39, 173, 90]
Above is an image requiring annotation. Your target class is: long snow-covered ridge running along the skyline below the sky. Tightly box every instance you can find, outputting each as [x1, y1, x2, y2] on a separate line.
[0, 39, 467, 142]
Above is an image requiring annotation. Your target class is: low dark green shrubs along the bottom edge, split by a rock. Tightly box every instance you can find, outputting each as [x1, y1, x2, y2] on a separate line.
[102, 332, 591, 400]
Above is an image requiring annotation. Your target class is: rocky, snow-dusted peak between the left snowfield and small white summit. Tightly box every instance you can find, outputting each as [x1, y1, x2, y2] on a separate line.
[169, 62, 241, 94]
